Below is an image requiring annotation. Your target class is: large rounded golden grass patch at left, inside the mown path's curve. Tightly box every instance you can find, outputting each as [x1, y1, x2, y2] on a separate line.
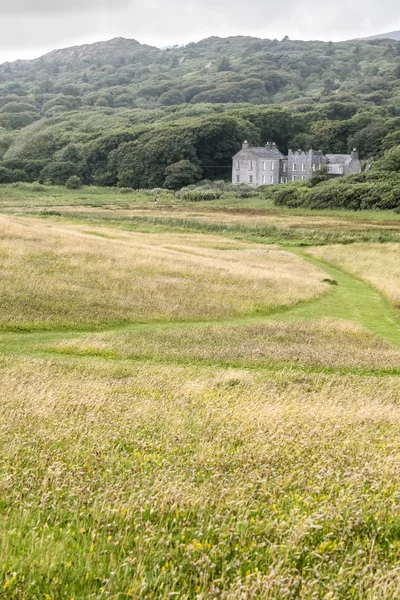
[0, 216, 327, 328]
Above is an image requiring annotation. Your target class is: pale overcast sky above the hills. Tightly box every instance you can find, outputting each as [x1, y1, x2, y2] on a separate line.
[0, 0, 400, 62]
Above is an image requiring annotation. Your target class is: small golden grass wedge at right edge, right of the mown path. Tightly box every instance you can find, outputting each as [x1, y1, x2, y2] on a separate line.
[308, 244, 400, 308]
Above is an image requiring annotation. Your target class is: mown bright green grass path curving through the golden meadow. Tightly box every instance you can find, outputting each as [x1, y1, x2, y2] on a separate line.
[0, 248, 400, 354]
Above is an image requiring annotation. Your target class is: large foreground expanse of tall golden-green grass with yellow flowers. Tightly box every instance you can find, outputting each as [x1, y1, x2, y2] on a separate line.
[0, 358, 400, 600]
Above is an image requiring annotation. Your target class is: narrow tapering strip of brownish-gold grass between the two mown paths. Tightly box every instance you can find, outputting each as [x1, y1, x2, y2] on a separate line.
[48, 318, 400, 369]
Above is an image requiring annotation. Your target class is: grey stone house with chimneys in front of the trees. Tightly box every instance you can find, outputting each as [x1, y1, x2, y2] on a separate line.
[232, 141, 362, 188]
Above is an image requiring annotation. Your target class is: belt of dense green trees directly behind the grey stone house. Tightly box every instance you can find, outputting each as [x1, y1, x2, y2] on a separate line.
[0, 96, 400, 189]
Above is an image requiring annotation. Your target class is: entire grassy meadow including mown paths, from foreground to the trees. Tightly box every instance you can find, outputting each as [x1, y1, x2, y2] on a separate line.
[0, 187, 400, 600]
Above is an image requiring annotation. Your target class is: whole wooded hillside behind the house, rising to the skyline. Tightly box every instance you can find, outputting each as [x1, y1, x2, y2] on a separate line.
[0, 37, 400, 208]
